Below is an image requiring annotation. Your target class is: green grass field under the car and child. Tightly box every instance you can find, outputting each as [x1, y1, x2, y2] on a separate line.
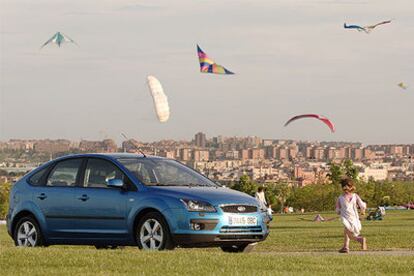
[0, 211, 414, 275]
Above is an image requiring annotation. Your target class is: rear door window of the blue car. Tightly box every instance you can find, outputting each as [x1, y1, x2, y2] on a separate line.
[46, 159, 82, 187]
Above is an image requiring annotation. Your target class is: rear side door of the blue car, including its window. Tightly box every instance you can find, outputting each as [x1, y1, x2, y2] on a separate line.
[33, 158, 82, 239]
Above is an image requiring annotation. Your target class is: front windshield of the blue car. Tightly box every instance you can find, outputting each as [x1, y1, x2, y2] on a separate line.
[118, 158, 217, 187]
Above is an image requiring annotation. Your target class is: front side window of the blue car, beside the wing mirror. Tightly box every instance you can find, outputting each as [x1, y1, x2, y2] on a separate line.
[83, 158, 126, 188]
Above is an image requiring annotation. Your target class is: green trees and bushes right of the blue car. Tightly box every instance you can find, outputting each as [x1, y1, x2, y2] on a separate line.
[230, 160, 414, 212]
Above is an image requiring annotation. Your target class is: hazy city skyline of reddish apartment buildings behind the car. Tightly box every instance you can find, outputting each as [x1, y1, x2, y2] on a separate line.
[0, 132, 414, 186]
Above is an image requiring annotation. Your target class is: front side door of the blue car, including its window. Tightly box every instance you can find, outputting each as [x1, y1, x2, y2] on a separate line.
[71, 158, 129, 240]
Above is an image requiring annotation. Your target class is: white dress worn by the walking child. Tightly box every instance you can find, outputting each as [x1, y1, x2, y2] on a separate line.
[336, 194, 367, 237]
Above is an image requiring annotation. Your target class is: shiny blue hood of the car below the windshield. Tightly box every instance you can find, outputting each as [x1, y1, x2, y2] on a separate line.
[150, 186, 259, 206]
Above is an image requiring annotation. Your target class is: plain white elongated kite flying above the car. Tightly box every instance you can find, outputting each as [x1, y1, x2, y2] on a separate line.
[147, 76, 170, 123]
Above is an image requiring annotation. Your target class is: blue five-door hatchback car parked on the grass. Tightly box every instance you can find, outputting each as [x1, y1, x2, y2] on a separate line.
[7, 153, 269, 252]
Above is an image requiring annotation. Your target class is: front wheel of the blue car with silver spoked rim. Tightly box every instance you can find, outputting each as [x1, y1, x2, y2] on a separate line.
[135, 212, 174, 250]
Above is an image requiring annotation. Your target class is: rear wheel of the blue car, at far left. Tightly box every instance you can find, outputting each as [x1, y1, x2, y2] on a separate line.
[13, 216, 44, 247]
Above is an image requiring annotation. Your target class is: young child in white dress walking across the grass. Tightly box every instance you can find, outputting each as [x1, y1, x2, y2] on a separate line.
[336, 179, 367, 253]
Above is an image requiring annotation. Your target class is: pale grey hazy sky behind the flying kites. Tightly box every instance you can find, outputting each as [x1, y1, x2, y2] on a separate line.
[0, 0, 414, 144]
